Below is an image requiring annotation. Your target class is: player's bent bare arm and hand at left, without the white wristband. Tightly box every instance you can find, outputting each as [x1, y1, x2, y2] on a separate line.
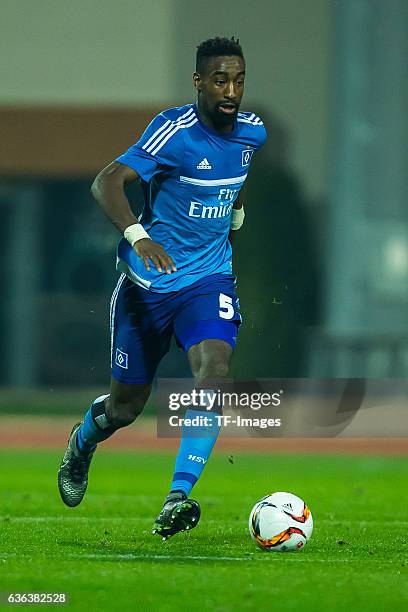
[91, 162, 176, 274]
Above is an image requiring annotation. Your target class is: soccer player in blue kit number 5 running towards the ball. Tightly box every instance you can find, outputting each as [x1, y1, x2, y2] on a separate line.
[58, 38, 266, 539]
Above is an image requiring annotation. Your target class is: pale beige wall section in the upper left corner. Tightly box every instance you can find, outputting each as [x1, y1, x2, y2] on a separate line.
[0, 0, 177, 106]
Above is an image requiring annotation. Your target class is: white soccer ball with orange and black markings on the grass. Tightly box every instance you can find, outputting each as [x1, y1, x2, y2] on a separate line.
[249, 493, 313, 552]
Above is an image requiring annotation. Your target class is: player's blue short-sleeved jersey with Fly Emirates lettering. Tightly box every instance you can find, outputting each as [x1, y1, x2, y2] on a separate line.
[116, 104, 266, 293]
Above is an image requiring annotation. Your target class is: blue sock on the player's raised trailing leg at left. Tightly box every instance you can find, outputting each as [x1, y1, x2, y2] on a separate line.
[77, 395, 116, 454]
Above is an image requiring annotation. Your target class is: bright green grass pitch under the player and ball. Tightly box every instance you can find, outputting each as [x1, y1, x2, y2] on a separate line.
[0, 449, 408, 612]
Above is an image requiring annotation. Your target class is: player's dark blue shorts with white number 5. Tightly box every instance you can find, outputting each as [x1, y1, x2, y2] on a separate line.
[110, 274, 241, 384]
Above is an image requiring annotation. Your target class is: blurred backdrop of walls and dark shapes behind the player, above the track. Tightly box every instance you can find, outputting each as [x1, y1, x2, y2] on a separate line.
[0, 0, 408, 409]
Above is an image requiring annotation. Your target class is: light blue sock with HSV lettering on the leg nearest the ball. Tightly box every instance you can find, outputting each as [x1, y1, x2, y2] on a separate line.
[171, 408, 220, 497]
